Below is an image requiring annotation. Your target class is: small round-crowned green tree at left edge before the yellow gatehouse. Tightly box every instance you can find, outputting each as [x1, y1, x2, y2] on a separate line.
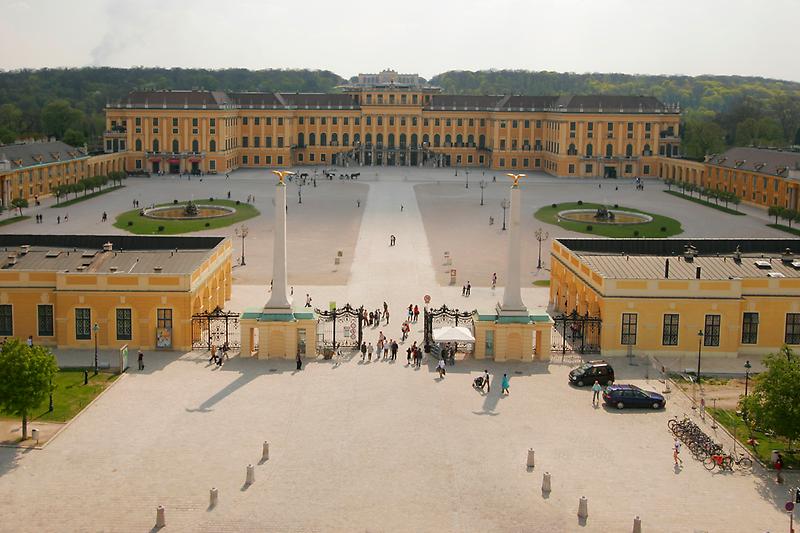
[0, 338, 58, 440]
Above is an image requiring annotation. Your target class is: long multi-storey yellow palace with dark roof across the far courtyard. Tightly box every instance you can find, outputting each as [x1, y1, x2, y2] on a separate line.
[104, 87, 680, 177]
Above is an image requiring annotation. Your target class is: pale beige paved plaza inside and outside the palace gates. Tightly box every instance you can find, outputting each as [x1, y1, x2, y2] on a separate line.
[0, 169, 795, 532]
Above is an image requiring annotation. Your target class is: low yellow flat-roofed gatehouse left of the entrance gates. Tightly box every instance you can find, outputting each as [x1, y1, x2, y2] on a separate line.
[0, 235, 231, 350]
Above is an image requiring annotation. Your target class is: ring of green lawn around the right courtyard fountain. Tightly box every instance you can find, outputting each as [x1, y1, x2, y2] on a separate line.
[533, 202, 683, 238]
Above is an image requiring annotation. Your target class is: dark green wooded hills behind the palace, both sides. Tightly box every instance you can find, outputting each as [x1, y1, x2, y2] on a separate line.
[0, 67, 800, 158]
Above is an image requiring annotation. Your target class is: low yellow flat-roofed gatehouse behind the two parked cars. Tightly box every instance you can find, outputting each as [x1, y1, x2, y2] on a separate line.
[550, 238, 800, 357]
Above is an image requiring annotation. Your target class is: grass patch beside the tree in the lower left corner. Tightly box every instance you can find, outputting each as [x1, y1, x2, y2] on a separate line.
[0, 369, 117, 422]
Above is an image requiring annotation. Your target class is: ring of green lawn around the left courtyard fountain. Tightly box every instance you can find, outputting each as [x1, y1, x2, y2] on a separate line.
[114, 198, 260, 235]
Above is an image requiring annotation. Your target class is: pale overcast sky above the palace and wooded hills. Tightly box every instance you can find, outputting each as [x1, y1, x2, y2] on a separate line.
[0, 0, 800, 81]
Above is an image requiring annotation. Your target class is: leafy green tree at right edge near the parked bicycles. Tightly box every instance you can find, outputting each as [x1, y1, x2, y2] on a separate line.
[739, 345, 800, 446]
